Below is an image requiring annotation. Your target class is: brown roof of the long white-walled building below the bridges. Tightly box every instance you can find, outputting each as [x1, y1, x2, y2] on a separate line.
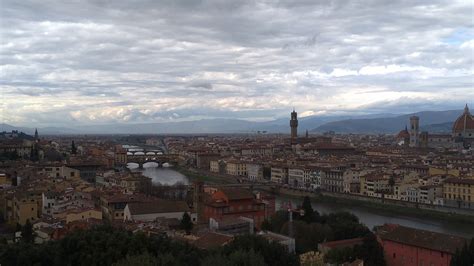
[128, 200, 193, 215]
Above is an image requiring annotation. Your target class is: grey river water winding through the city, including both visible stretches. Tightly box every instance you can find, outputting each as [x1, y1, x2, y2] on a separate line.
[128, 163, 474, 238]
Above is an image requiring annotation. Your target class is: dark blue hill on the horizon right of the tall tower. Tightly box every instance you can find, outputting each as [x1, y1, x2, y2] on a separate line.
[312, 110, 462, 134]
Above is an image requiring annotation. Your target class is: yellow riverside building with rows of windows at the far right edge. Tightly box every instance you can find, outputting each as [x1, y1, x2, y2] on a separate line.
[443, 178, 474, 209]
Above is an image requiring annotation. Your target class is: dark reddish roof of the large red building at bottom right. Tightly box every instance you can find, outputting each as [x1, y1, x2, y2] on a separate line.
[376, 224, 467, 254]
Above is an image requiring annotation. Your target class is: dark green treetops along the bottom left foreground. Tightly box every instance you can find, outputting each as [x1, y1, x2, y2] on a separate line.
[0, 225, 298, 266]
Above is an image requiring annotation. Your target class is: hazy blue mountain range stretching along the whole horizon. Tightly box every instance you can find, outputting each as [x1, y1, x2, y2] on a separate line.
[0, 110, 462, 135]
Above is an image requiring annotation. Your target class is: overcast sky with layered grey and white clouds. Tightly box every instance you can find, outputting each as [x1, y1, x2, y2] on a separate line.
[0, 0, 474, 126]
